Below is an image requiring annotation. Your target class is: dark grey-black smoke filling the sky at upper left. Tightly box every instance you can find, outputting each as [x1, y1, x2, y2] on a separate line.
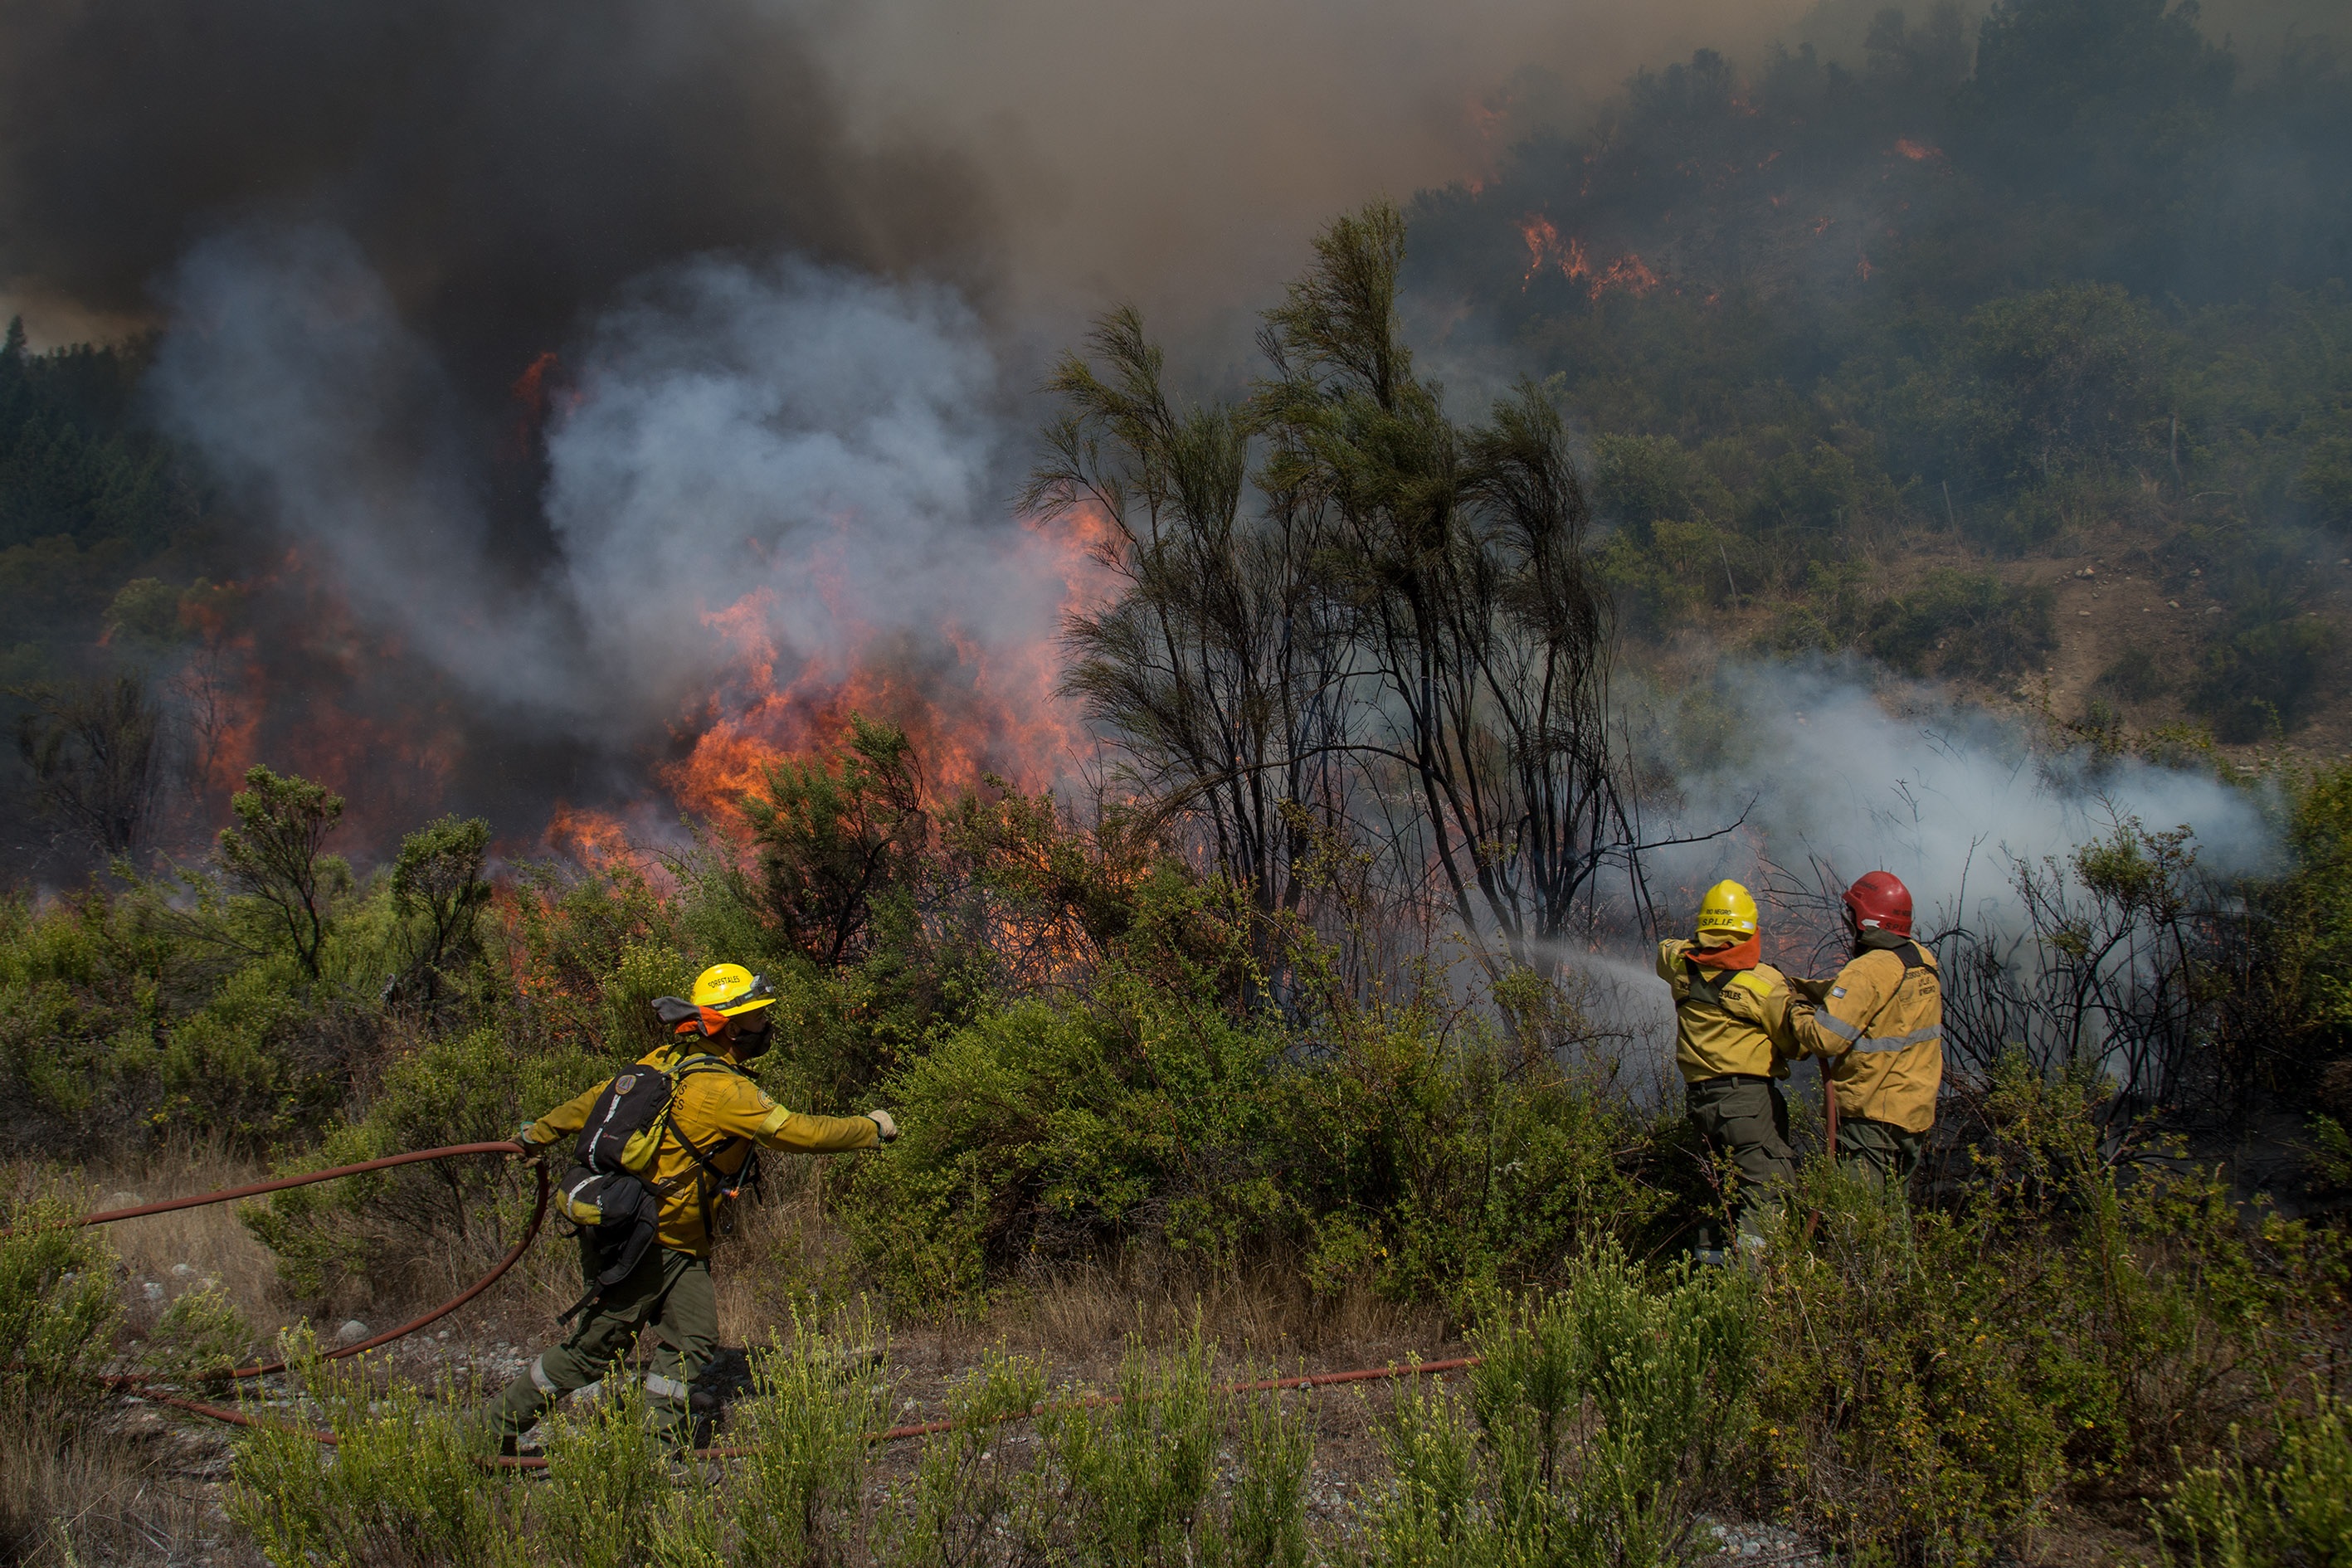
[0, 0, 988, 383]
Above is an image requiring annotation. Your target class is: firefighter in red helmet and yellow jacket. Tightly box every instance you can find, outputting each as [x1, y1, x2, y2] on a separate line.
[1790, 872, 1943, 1190]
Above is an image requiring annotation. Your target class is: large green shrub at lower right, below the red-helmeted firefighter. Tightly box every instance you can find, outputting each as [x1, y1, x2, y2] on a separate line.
[1757, 1055, 2340, 1563]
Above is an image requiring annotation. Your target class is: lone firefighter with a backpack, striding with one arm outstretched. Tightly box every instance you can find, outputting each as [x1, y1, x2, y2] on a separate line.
[494, 964, 898, 1455]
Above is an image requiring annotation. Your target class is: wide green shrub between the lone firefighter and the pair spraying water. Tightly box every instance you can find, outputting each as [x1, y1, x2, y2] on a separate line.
[842, 967, 1668, 1312]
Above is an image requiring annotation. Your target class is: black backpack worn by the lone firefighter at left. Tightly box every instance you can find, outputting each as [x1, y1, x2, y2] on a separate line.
[555, 996, 734, 1323]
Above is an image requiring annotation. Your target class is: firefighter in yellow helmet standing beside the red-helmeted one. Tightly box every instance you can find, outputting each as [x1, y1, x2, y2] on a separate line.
[1658, 882, 1797, 1263]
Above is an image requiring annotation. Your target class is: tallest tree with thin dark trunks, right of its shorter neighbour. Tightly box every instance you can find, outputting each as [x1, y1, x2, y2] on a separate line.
[1256, 205, 1642, 967]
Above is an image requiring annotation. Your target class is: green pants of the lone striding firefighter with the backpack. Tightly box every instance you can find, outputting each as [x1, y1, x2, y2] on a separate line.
[494, 1234, 720, 1448]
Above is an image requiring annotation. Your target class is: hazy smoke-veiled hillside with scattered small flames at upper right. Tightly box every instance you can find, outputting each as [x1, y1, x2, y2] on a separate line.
[1409, 0, 2352, 750]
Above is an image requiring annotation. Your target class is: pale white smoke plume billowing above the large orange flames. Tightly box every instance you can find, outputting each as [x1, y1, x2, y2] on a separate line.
[153, 231, 1065, 738]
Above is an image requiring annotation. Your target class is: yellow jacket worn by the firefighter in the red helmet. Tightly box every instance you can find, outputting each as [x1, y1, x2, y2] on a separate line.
[1792, 933, 1943, 1133]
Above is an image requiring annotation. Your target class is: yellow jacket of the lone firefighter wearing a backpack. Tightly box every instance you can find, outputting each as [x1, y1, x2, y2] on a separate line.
[522, 1049, 882, 1258]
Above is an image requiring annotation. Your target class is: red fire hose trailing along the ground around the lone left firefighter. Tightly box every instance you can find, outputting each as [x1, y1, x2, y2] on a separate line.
[18, 1147, 1477, 1469]
